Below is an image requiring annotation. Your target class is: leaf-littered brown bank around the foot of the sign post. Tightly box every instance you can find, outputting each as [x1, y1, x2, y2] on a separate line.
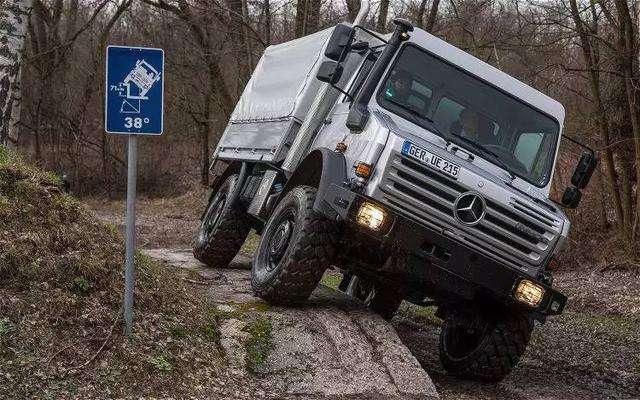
[0, 147, 224, 399]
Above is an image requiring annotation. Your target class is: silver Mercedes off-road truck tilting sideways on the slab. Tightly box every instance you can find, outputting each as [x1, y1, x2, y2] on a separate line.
[194, 7, 596, 381]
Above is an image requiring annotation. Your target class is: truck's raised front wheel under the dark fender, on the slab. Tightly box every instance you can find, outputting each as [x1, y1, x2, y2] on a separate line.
[251, 186, 336, 305]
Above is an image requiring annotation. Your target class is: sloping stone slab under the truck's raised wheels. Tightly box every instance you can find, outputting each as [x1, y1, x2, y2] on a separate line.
[146, 249, 438, 399]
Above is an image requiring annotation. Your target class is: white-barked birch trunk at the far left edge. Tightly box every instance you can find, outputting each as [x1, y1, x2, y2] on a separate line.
[0, 0, 33, 146]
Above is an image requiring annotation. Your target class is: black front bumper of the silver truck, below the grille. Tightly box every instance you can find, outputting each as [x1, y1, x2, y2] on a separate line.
[324, 184, 567, 317]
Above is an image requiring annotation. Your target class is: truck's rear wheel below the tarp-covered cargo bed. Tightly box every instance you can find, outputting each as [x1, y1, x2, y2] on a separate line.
[193, 175, 251, 268]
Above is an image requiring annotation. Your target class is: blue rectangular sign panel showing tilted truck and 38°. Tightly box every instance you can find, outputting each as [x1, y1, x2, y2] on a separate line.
[104, 46, 164, 135]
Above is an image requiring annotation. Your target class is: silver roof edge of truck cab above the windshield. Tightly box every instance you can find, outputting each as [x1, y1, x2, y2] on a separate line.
[409, 28, 565, 124]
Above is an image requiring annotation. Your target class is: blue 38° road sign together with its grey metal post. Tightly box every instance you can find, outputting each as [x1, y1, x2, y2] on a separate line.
[104, 46, 164, 336]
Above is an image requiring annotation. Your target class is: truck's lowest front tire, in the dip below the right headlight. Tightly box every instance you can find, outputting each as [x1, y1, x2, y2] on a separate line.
[439, 314, 533, 382]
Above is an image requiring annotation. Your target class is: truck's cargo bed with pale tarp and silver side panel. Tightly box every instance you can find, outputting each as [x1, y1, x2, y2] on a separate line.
[216, 28, 333, 162]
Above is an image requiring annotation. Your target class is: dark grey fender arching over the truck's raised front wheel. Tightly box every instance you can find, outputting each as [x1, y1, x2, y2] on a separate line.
[282, 147, 355, 220]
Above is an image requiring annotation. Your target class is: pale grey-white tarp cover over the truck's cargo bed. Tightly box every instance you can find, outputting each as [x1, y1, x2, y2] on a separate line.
[231, 28, 333, 122]
